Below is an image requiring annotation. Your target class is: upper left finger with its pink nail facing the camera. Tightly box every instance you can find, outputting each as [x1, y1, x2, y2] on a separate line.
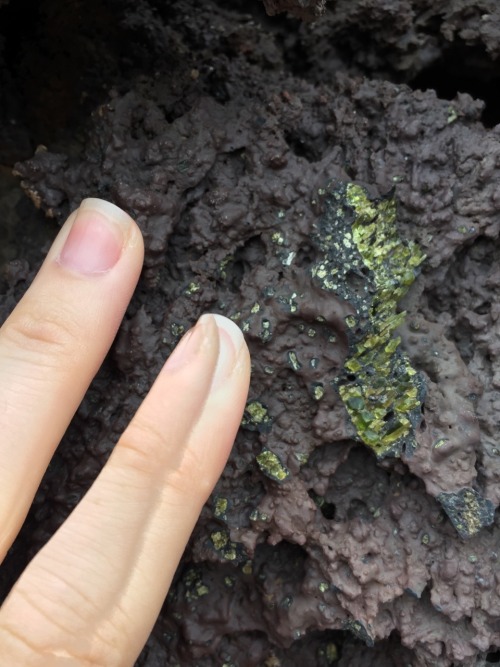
[0, 199, 143, 562]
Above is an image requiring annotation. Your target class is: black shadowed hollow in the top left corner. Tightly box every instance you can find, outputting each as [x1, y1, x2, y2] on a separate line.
[0, 0, 123, 149]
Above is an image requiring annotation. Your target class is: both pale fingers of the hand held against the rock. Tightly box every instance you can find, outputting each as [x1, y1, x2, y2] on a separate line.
[0, 199, 250, 667]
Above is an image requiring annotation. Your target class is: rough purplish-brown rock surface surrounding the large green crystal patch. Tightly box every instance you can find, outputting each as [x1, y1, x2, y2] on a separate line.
[0, 0, 500, 667]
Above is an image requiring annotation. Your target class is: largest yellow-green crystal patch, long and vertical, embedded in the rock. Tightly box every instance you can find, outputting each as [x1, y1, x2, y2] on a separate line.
[312, 183, 425, 456]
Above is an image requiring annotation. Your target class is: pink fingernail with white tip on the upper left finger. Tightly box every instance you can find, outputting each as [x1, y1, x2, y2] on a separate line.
[57, 199, 132, 275]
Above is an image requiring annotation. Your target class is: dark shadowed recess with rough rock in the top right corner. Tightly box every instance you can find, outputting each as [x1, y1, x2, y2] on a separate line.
[288, 0, 500, 126]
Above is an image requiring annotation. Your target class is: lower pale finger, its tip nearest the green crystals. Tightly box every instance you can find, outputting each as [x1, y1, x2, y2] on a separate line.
[0, 316, 250, 667]
